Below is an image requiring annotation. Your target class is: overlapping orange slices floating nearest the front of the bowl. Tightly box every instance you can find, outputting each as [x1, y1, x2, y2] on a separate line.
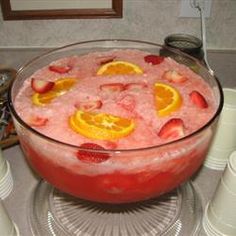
[69, 110, 134, 140]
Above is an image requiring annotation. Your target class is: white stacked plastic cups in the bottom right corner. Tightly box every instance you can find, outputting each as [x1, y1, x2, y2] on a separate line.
[203, 151, 236, 236]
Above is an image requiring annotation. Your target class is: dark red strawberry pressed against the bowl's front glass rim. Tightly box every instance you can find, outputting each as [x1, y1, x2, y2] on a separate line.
[76, 143, 110, 163]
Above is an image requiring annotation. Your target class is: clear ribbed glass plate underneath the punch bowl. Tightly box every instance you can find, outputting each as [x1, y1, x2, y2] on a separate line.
[28, 181, 202, 236]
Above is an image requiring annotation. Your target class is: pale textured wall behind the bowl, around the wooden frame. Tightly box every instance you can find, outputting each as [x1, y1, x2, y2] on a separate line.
[0, 0, 236, 50]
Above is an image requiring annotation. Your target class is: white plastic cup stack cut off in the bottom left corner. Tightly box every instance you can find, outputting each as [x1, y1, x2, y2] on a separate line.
[0, 200, 19, 236]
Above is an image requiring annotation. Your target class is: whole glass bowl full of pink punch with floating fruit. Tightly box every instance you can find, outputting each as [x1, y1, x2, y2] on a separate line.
[9, 40, 223, 203]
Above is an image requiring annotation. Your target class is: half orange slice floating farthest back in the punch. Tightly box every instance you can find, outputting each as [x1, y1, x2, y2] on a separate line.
[97, 61, 143, 75]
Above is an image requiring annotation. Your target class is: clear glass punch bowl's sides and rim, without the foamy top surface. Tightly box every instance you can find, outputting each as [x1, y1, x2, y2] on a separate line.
[9, 40, 223, 203]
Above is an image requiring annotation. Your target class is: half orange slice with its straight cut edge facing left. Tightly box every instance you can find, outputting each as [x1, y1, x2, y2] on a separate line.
[155, 83, 182, 117]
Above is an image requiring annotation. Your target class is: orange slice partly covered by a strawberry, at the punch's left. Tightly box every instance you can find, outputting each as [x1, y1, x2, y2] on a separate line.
[32, 78, 78, 106]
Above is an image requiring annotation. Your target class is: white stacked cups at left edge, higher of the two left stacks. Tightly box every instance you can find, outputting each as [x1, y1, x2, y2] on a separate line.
[0, 149, 13, 200]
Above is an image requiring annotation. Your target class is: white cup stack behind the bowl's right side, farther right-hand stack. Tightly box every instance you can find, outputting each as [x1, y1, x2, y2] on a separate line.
[204, 88, 236, 170]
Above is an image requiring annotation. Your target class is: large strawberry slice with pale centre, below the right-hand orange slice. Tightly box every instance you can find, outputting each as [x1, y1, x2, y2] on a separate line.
[158, 118, 184, 139]
